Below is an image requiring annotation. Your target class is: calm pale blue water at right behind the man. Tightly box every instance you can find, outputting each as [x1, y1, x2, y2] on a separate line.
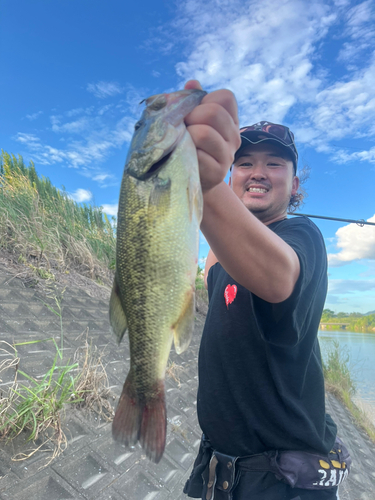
[319, 330, 375, 407]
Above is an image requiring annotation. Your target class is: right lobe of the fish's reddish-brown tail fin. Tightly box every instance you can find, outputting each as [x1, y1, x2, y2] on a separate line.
[139, 381, 167, 463]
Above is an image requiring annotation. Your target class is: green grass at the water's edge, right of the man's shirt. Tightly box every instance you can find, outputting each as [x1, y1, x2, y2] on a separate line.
[323, 340, 375, 443]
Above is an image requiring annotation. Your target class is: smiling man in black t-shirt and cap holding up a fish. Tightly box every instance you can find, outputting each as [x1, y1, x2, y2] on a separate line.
[184, 81, 346, 500]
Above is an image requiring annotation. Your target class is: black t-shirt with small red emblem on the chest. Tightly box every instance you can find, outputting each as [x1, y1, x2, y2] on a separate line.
[197, 217, 337, 456]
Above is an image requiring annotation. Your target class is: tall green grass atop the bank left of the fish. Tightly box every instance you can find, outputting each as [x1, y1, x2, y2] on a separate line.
[0, 151, 116, 283]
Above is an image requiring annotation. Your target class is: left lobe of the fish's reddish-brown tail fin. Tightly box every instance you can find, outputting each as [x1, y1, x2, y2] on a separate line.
[112, 372, 142, 446]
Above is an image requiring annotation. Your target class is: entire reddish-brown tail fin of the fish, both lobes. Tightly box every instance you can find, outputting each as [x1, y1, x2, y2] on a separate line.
[112, 373, 167, 463]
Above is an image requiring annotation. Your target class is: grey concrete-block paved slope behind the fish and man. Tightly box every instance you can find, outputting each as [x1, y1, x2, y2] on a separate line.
[0, 266, 375, 500]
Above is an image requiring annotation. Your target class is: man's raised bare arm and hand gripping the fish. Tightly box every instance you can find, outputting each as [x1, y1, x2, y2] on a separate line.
[185, 80, 300, 303]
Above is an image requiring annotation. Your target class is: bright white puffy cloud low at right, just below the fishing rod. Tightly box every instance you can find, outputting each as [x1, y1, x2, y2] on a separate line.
[328, 215, 375, 267]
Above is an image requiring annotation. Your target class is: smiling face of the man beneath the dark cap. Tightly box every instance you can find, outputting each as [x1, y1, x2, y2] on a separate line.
[229, 142, 299, 224]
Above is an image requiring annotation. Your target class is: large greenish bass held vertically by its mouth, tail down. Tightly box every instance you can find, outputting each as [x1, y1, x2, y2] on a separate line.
[109, 89, 206, 463]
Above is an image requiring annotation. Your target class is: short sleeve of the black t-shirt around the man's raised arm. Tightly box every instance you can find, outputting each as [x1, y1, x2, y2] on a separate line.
[253, 217, 327, 346]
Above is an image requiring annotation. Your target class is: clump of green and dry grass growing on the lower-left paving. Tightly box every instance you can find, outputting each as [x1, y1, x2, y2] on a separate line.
[0, 332, 114, 467]
